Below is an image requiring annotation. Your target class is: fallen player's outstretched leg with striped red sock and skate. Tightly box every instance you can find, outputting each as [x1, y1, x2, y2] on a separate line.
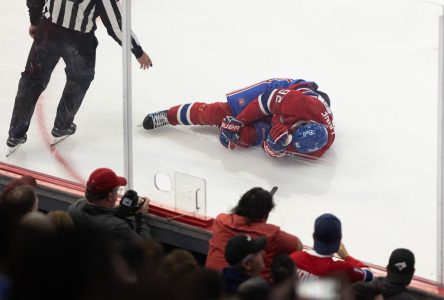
[143, 102, 231, 130]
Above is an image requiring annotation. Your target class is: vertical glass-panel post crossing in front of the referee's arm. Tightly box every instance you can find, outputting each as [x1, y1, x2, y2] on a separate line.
[121, 0, 134, 189]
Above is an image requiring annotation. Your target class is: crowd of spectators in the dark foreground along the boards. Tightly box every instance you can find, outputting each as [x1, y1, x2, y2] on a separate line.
[0, 168, 432, 300]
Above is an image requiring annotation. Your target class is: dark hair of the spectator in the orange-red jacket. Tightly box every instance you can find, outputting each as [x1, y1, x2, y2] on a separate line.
[231, 187, 275, 223]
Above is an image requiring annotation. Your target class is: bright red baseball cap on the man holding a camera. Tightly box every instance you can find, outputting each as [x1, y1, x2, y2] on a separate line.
[86, 168, 127, 192]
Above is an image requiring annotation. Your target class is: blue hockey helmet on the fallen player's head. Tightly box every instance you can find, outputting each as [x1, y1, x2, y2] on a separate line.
[292, 122, 328, 153]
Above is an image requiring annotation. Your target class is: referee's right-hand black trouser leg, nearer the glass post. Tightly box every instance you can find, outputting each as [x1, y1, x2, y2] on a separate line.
[54, 35, 97, 129]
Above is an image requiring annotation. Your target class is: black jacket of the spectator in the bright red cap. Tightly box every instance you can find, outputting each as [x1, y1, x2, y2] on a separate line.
[68, 199, 151, 241]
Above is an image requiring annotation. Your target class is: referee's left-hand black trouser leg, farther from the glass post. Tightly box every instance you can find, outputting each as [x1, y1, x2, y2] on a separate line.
[9, 25, 60, 138]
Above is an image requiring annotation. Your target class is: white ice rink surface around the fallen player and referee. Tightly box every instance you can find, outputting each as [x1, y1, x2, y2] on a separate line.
[0, 0, 442, 279]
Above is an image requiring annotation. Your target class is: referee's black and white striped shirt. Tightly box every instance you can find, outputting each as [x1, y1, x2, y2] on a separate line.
[27, 0, 143, 58]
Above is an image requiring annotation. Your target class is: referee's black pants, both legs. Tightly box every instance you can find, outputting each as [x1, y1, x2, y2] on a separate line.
[9, 19, 98, 138]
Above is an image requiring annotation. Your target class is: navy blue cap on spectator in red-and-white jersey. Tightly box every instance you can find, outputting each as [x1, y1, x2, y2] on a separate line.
[313, 214, 342, 255]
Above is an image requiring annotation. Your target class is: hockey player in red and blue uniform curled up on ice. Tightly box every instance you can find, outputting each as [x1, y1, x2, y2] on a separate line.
[143, 79, 335, 158]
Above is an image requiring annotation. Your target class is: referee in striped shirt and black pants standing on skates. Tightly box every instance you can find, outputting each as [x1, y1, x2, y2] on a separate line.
[6, 0, 152, 155]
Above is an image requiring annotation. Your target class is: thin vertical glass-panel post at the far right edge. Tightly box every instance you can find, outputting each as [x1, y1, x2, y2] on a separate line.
[436, 14, 444, 285]
